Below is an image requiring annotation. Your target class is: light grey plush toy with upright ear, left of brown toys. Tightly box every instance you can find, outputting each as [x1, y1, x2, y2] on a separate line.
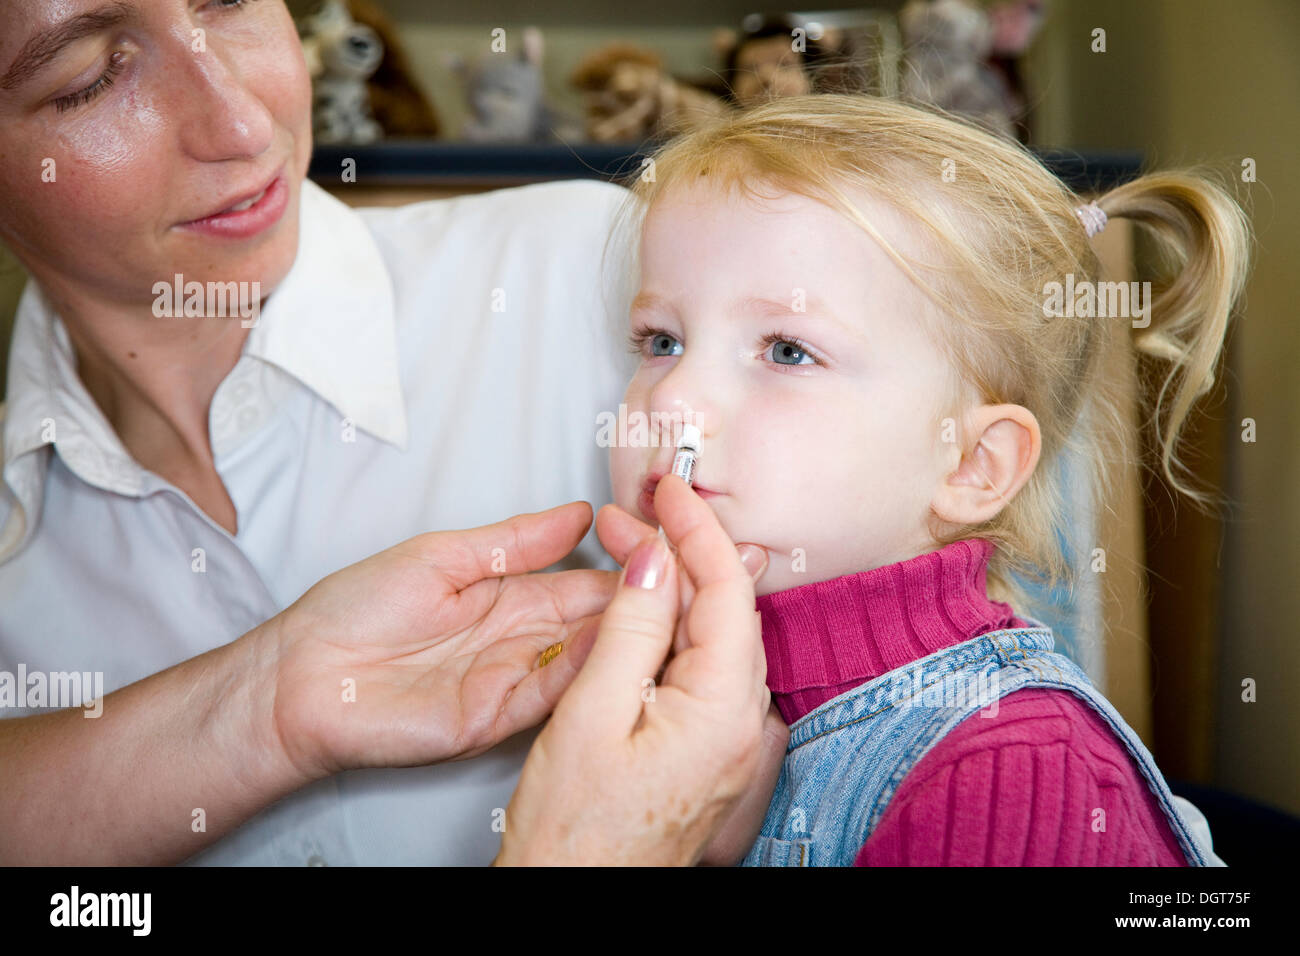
[446, 27, 577, 143]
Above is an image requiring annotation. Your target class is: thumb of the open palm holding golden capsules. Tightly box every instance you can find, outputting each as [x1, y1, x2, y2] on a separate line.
[403, 501, 592, 591]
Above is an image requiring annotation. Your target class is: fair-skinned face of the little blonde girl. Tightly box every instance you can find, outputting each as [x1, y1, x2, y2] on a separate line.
[610, 183, 956, 594]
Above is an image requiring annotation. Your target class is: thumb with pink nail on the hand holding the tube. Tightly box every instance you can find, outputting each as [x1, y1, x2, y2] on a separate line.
[559, 535, 681, 736]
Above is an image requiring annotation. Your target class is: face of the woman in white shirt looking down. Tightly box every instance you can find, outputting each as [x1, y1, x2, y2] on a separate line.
[0, 0, 312, 306]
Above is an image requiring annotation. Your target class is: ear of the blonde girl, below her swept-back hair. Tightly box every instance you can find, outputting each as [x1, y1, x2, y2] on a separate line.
[931, 405, 1041, 525]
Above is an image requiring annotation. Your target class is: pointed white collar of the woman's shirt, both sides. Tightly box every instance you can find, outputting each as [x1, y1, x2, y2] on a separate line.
[0, 179, 407, 562]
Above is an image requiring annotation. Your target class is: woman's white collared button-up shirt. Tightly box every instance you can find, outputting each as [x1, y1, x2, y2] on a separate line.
[0, 182, 632, 865]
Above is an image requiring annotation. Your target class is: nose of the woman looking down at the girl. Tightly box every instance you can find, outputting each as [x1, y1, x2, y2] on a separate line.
[174, 47, 274, 163]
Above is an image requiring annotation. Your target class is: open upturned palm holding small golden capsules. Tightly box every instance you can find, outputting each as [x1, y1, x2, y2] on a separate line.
[261, 502, 618, 780]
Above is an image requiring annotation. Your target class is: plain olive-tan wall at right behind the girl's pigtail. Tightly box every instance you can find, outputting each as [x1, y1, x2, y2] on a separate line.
[1028, 0, 1300, 813]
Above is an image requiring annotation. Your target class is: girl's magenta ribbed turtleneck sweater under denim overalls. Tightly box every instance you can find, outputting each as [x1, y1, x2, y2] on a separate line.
[758, 538, 1184, 866]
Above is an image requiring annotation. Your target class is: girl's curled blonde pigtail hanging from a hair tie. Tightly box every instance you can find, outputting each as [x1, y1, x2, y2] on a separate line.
[1097, 170, 1251, 503]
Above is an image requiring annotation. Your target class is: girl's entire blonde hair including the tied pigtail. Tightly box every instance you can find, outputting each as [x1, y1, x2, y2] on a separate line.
[616, 94, 1251, 614]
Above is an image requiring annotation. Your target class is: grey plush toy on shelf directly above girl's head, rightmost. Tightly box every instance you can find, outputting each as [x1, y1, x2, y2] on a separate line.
[898, 0, 1043, 138]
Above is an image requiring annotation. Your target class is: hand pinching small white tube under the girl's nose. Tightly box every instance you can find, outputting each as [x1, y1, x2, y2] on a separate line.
[497, 475, 771, 865]
